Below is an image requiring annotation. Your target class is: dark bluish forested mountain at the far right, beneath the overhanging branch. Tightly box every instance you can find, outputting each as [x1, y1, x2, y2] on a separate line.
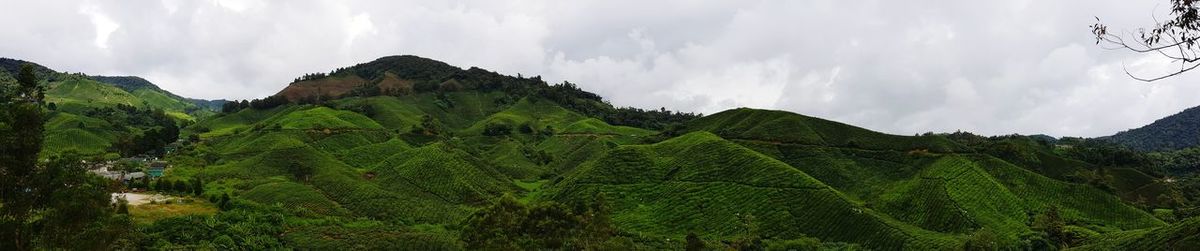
[1102, 107, 1200, 151]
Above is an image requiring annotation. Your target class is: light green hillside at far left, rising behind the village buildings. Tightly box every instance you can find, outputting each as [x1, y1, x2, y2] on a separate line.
[0, 58, 223, 155]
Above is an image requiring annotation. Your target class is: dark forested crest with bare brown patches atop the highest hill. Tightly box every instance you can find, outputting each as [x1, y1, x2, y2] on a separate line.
[259, 55, 700, 130]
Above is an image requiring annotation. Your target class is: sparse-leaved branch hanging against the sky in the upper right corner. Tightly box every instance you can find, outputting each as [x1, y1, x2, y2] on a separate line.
[1090, 0, 1200, 82]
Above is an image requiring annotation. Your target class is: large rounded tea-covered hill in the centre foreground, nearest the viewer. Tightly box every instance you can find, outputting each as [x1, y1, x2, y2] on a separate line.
[548, 132, 958, 249]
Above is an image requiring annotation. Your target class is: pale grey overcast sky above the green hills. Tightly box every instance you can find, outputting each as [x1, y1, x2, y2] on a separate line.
[0, 0, 1200, 137]
